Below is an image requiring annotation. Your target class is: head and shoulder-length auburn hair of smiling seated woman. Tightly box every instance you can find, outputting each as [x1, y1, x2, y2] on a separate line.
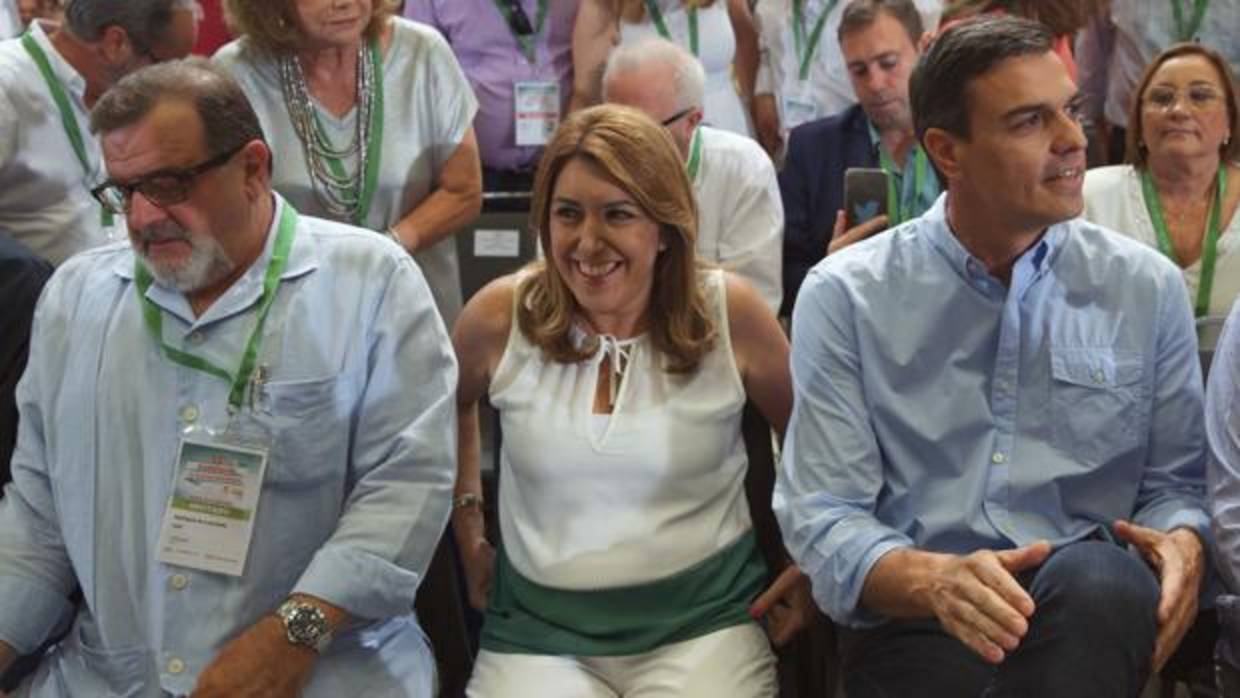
[517, 102, 715, 371]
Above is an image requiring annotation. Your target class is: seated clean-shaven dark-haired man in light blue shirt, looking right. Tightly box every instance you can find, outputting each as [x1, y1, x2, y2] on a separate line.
[776, 19, 1209, 698]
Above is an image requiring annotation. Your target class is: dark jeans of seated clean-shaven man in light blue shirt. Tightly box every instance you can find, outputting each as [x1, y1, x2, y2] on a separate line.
[841, 541, 1158, 698]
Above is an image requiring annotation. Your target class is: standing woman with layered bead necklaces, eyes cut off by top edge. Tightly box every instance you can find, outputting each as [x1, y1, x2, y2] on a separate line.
[215, 0, 482, 326]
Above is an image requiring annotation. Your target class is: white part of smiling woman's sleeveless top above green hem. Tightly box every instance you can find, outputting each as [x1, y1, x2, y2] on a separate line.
[490, 270, 751, 590]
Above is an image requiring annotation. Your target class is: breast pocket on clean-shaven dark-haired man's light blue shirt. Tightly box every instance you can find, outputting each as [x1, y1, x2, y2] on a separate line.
[1050, 347, 1145, 465]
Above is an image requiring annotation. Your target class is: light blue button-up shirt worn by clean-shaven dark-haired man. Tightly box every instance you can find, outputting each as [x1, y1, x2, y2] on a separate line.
[775, 195, 1208, 626]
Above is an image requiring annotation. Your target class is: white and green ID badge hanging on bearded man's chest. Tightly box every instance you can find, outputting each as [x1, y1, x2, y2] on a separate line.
[157, 420, 270, 577]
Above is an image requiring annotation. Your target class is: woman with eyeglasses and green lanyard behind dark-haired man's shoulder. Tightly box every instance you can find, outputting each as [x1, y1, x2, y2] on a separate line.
[1084, 43, 1240, 351]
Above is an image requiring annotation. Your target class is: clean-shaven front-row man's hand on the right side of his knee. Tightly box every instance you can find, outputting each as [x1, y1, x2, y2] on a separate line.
[1115, 521, 1205, 672]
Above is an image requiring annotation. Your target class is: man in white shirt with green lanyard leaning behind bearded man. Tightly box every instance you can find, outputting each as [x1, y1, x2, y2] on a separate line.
[0, 0, 197, 264]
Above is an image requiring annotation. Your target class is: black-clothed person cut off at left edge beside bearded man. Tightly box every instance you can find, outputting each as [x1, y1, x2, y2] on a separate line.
[0, 232, 52, 497]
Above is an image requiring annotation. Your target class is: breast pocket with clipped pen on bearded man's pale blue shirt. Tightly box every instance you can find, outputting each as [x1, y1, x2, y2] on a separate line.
[244, 371, 363, 488]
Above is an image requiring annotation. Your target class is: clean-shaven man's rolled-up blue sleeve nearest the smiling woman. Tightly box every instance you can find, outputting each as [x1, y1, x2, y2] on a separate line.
[774, 265, 913, 626]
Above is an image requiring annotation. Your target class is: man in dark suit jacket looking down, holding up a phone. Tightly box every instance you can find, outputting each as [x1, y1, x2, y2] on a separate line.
[779, 0, 939, 315]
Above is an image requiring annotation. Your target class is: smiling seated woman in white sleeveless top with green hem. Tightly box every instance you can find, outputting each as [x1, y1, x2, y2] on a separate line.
[453, 105, 812, 698]
